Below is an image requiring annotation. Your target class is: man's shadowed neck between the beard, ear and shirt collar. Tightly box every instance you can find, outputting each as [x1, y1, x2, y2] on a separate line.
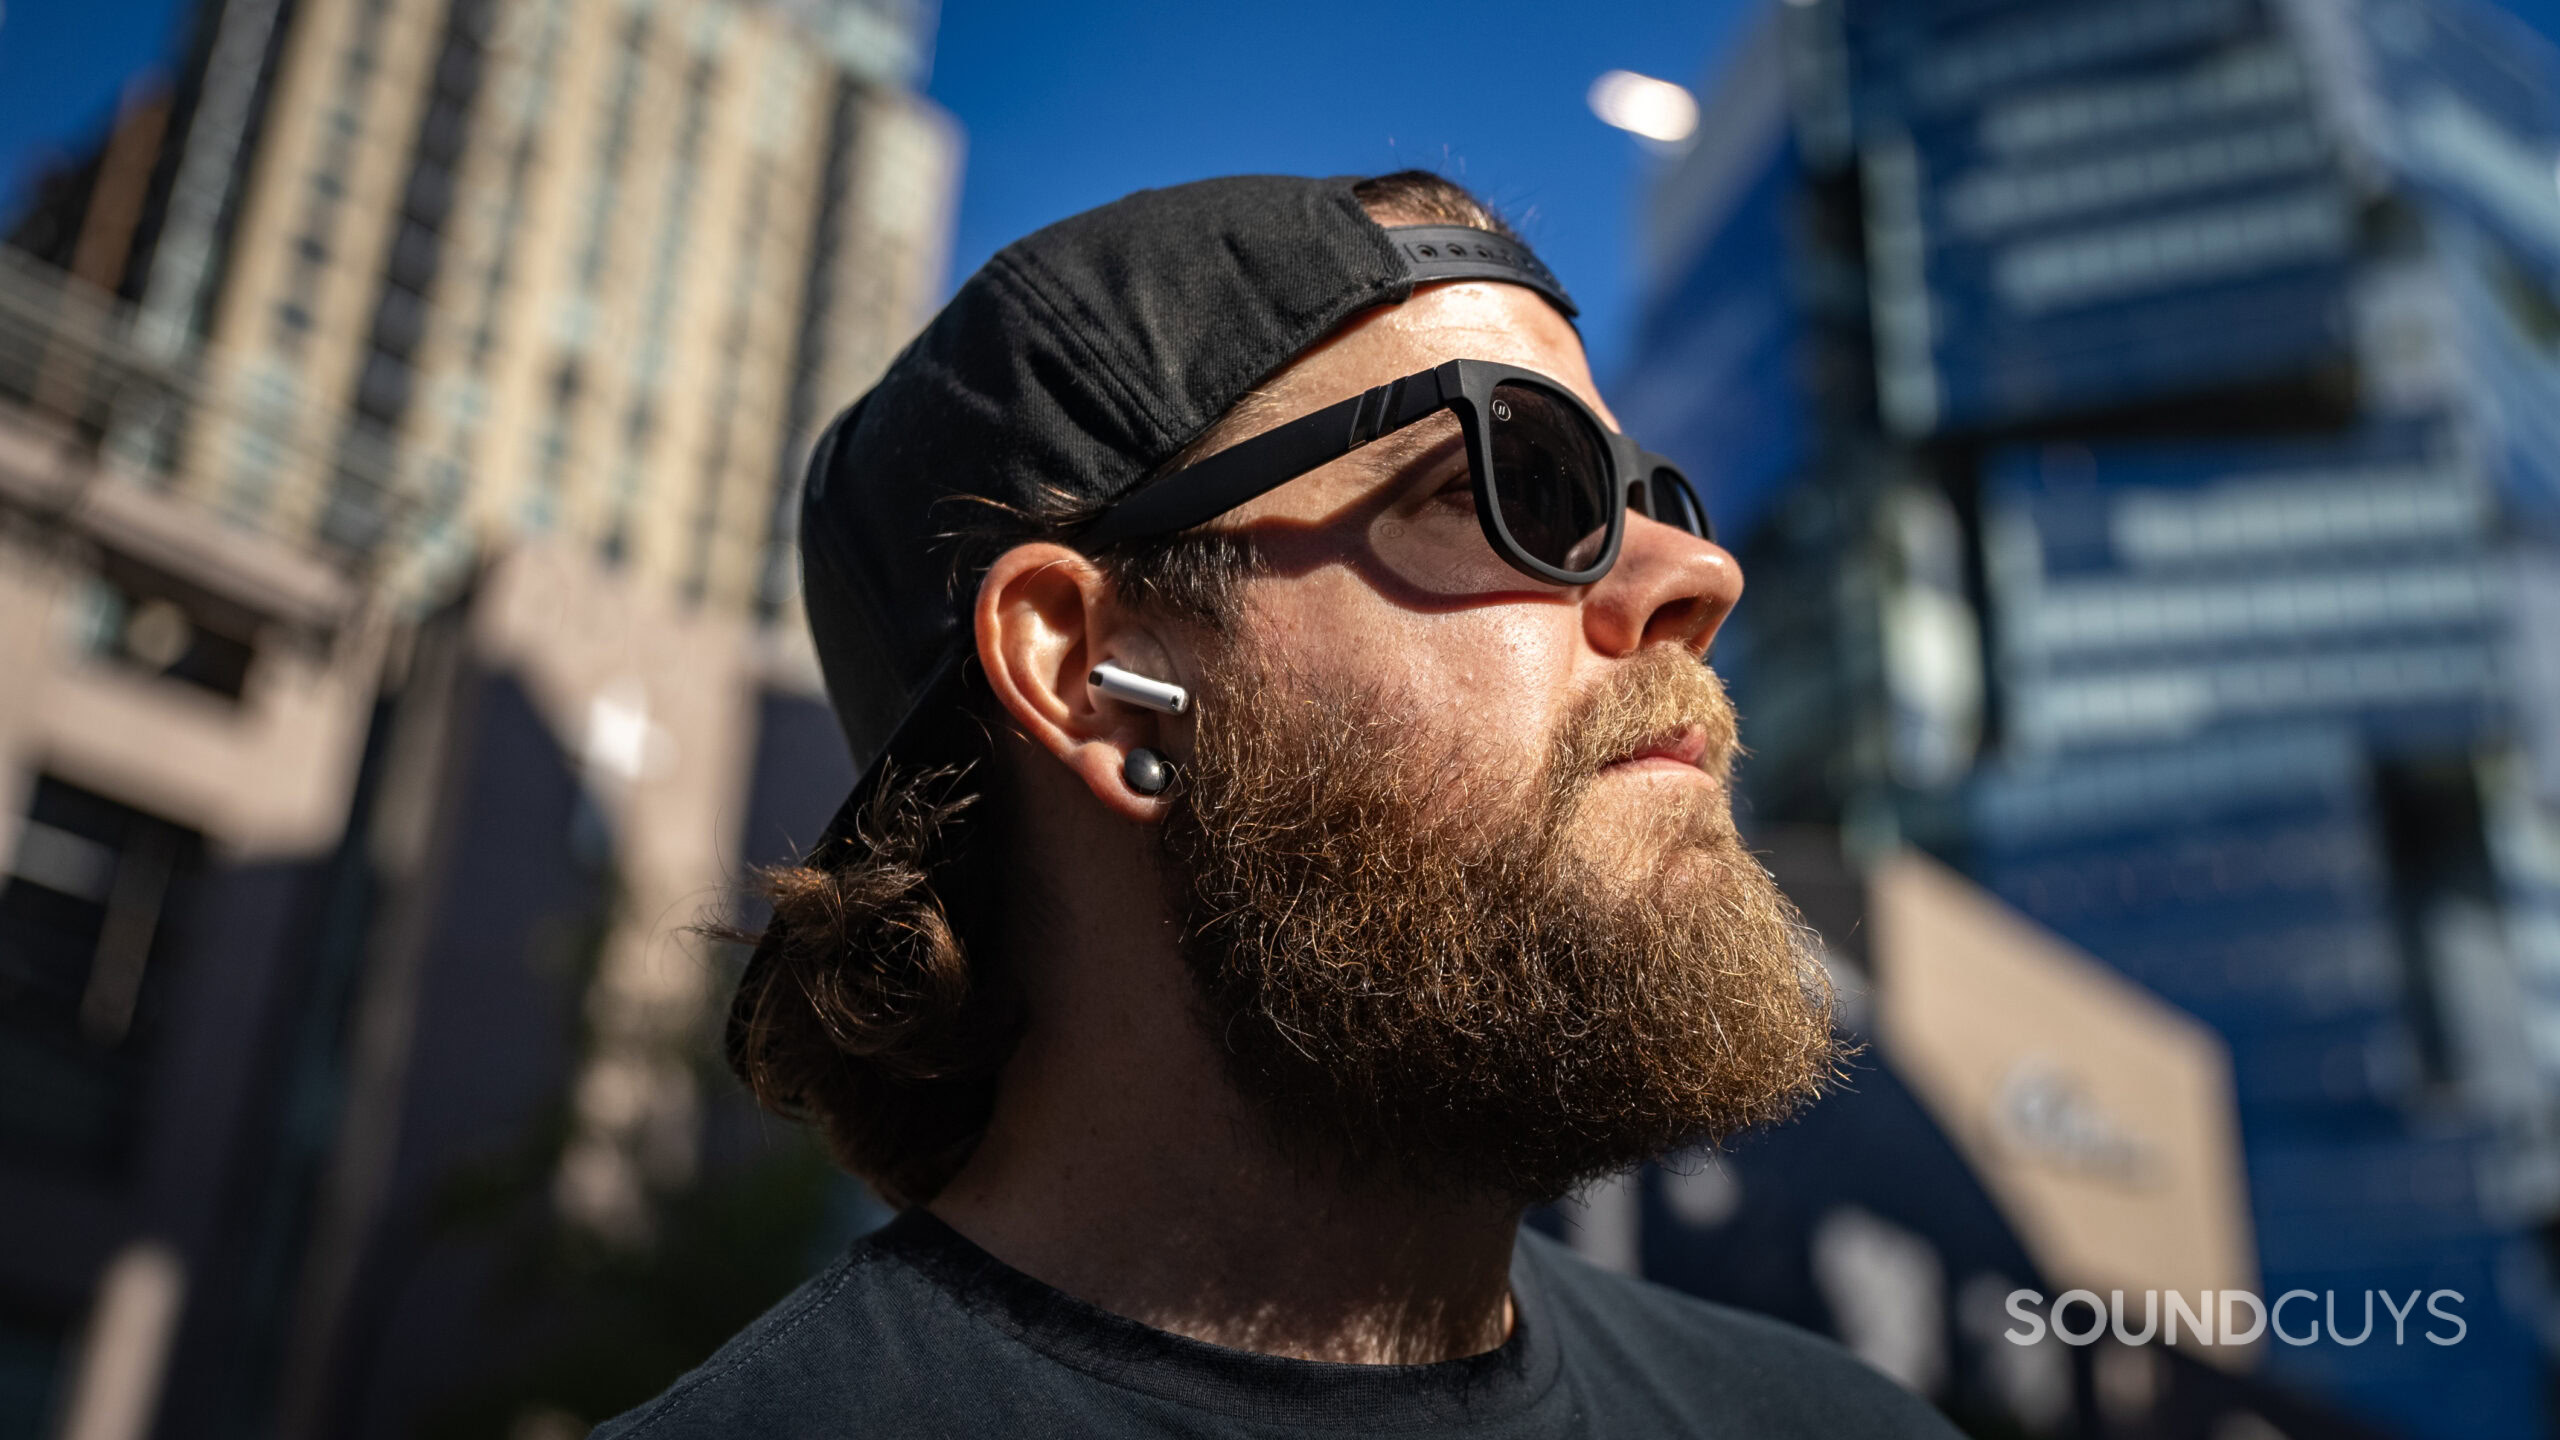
[932, 763, 1521, 1363]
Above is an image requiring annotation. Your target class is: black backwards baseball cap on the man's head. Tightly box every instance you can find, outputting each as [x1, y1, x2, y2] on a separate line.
[799, 174, 1574, 866]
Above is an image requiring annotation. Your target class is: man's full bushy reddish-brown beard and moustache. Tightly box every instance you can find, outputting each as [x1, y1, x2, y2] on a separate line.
[1165, 646, 1836, 1202]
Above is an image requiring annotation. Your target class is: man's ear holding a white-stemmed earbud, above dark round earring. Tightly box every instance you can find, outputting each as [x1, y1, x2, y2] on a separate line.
[973, 543, 1188, 822]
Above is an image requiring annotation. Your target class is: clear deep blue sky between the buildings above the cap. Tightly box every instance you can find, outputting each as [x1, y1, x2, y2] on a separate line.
[0, 0, 2560, 374]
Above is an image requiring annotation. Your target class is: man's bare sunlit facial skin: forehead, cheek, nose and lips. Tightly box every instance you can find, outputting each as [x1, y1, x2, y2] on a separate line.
[1192, 282, 1741, 869]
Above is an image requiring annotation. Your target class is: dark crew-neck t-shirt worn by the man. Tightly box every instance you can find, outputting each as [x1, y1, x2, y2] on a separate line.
[594, 1209, 1956, 1440]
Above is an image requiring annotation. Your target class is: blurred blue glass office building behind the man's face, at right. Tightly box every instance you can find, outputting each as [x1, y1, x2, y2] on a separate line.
[1620, 0, 2560, 1437]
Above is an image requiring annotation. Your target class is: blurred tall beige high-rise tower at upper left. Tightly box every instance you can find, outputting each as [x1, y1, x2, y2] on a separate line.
[141, 0, 957, 610]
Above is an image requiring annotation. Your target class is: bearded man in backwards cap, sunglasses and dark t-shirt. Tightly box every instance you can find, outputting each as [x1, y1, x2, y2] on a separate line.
[604, 172, 1948, 1437]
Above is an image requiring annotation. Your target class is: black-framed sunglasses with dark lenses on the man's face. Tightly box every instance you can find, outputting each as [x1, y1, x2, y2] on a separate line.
[1078, 359, 1715, 584]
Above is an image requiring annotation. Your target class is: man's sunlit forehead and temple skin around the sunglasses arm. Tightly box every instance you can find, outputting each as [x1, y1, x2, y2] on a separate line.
[1208, 279, 1618, 523]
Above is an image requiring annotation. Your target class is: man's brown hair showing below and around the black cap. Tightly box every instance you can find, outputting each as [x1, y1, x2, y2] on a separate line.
[712, 169, 1518, 1204]
